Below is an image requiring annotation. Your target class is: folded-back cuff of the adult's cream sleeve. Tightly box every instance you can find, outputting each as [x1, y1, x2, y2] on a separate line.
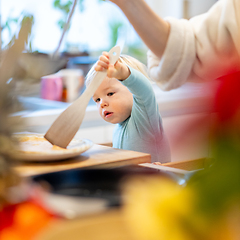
[148, 16, 196, 90]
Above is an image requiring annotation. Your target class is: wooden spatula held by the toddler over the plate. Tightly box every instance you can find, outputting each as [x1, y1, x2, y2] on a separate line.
[44, 46, 120, 148]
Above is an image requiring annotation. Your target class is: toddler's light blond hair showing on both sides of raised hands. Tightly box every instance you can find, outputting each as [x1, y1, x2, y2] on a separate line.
[85, 55, 150, 87]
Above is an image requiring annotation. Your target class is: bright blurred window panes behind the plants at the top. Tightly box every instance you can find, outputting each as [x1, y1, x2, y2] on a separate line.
[1, 0, 144, 60]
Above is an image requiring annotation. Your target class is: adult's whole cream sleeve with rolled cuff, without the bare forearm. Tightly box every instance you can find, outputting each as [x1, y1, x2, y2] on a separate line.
[148, 0, 240, 90]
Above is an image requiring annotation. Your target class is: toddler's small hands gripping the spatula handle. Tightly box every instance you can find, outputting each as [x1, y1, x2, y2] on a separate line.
[95, 52, 130, 81]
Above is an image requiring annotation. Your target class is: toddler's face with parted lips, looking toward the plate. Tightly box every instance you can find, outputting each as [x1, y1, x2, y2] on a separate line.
[93, 77, 133, 124]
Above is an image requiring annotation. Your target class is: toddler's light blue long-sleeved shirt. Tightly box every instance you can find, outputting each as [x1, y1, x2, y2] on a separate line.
[113, 67, 171, 163]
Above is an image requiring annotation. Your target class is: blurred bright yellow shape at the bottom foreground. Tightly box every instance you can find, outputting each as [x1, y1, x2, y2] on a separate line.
[124, 177, 195, 240]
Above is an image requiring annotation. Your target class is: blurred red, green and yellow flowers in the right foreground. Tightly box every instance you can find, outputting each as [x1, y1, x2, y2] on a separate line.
[125, 73, 240, 240]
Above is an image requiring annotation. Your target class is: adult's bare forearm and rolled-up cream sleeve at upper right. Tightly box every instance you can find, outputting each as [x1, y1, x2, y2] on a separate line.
[111, 0, 240, 90]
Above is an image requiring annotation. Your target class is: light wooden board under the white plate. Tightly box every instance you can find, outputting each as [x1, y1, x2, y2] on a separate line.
[14, 144, 151, 176]
